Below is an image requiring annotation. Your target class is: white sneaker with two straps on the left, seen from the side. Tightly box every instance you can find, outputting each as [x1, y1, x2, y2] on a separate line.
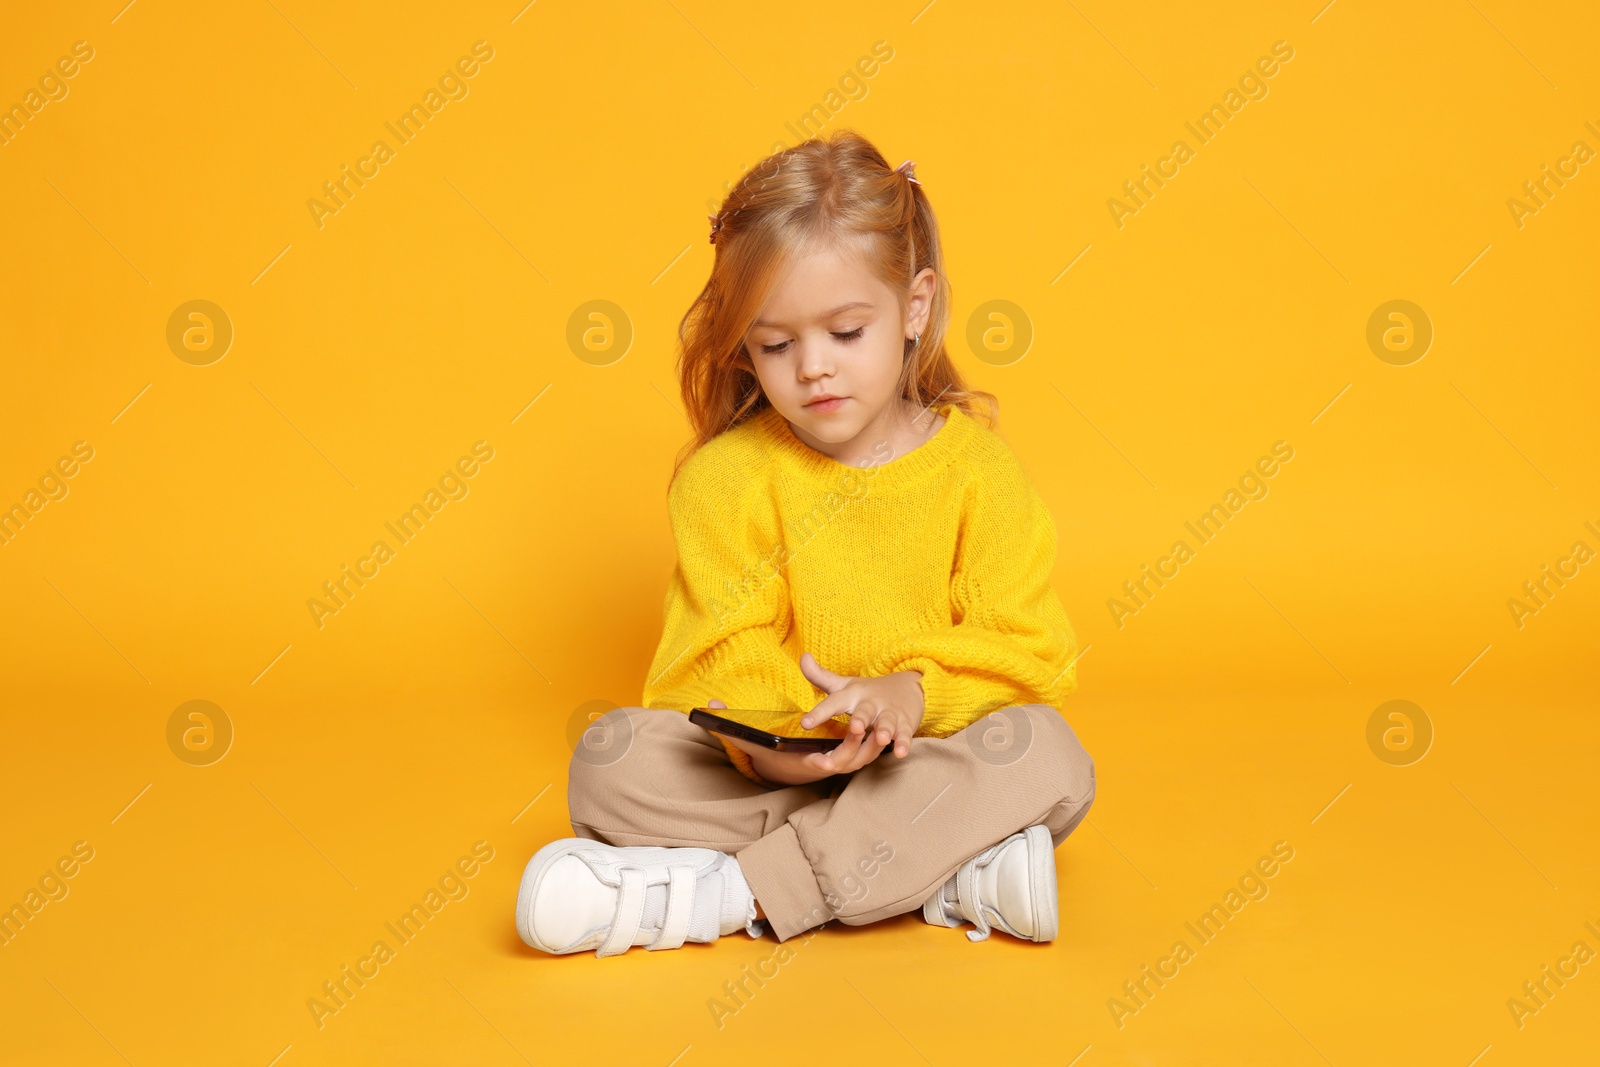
[517, 837, 763, 957]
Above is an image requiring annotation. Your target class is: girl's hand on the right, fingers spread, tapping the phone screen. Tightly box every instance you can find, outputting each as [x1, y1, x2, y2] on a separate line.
[800, 653, 925, 774]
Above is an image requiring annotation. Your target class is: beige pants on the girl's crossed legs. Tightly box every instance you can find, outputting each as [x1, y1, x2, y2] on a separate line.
[566, 704, 1094, 941]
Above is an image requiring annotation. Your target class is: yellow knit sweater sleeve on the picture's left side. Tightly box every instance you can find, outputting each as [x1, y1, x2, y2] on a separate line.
[642, 445, 818, 785]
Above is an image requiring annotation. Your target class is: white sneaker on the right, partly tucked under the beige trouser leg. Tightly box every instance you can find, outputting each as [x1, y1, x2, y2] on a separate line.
[922, 824, 1059, 941]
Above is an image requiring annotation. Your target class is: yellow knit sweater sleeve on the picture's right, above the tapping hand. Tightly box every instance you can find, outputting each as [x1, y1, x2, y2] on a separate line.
[867, 448, 1077, 737]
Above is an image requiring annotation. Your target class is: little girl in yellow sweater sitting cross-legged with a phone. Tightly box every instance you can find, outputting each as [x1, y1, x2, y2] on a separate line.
[517, 131, 1094, 955]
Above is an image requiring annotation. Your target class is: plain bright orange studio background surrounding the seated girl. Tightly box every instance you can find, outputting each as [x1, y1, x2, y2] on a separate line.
[0, 0, 1600, 1067]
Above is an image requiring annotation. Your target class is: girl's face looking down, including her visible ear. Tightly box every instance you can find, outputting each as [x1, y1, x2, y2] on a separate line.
[744, 239, 934, 461]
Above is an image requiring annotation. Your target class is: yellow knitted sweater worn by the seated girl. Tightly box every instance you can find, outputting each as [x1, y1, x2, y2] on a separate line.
[642, 405, 1077, 782]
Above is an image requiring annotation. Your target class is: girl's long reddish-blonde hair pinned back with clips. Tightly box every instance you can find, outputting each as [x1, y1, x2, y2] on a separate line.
[672, 130, 998, 489]
